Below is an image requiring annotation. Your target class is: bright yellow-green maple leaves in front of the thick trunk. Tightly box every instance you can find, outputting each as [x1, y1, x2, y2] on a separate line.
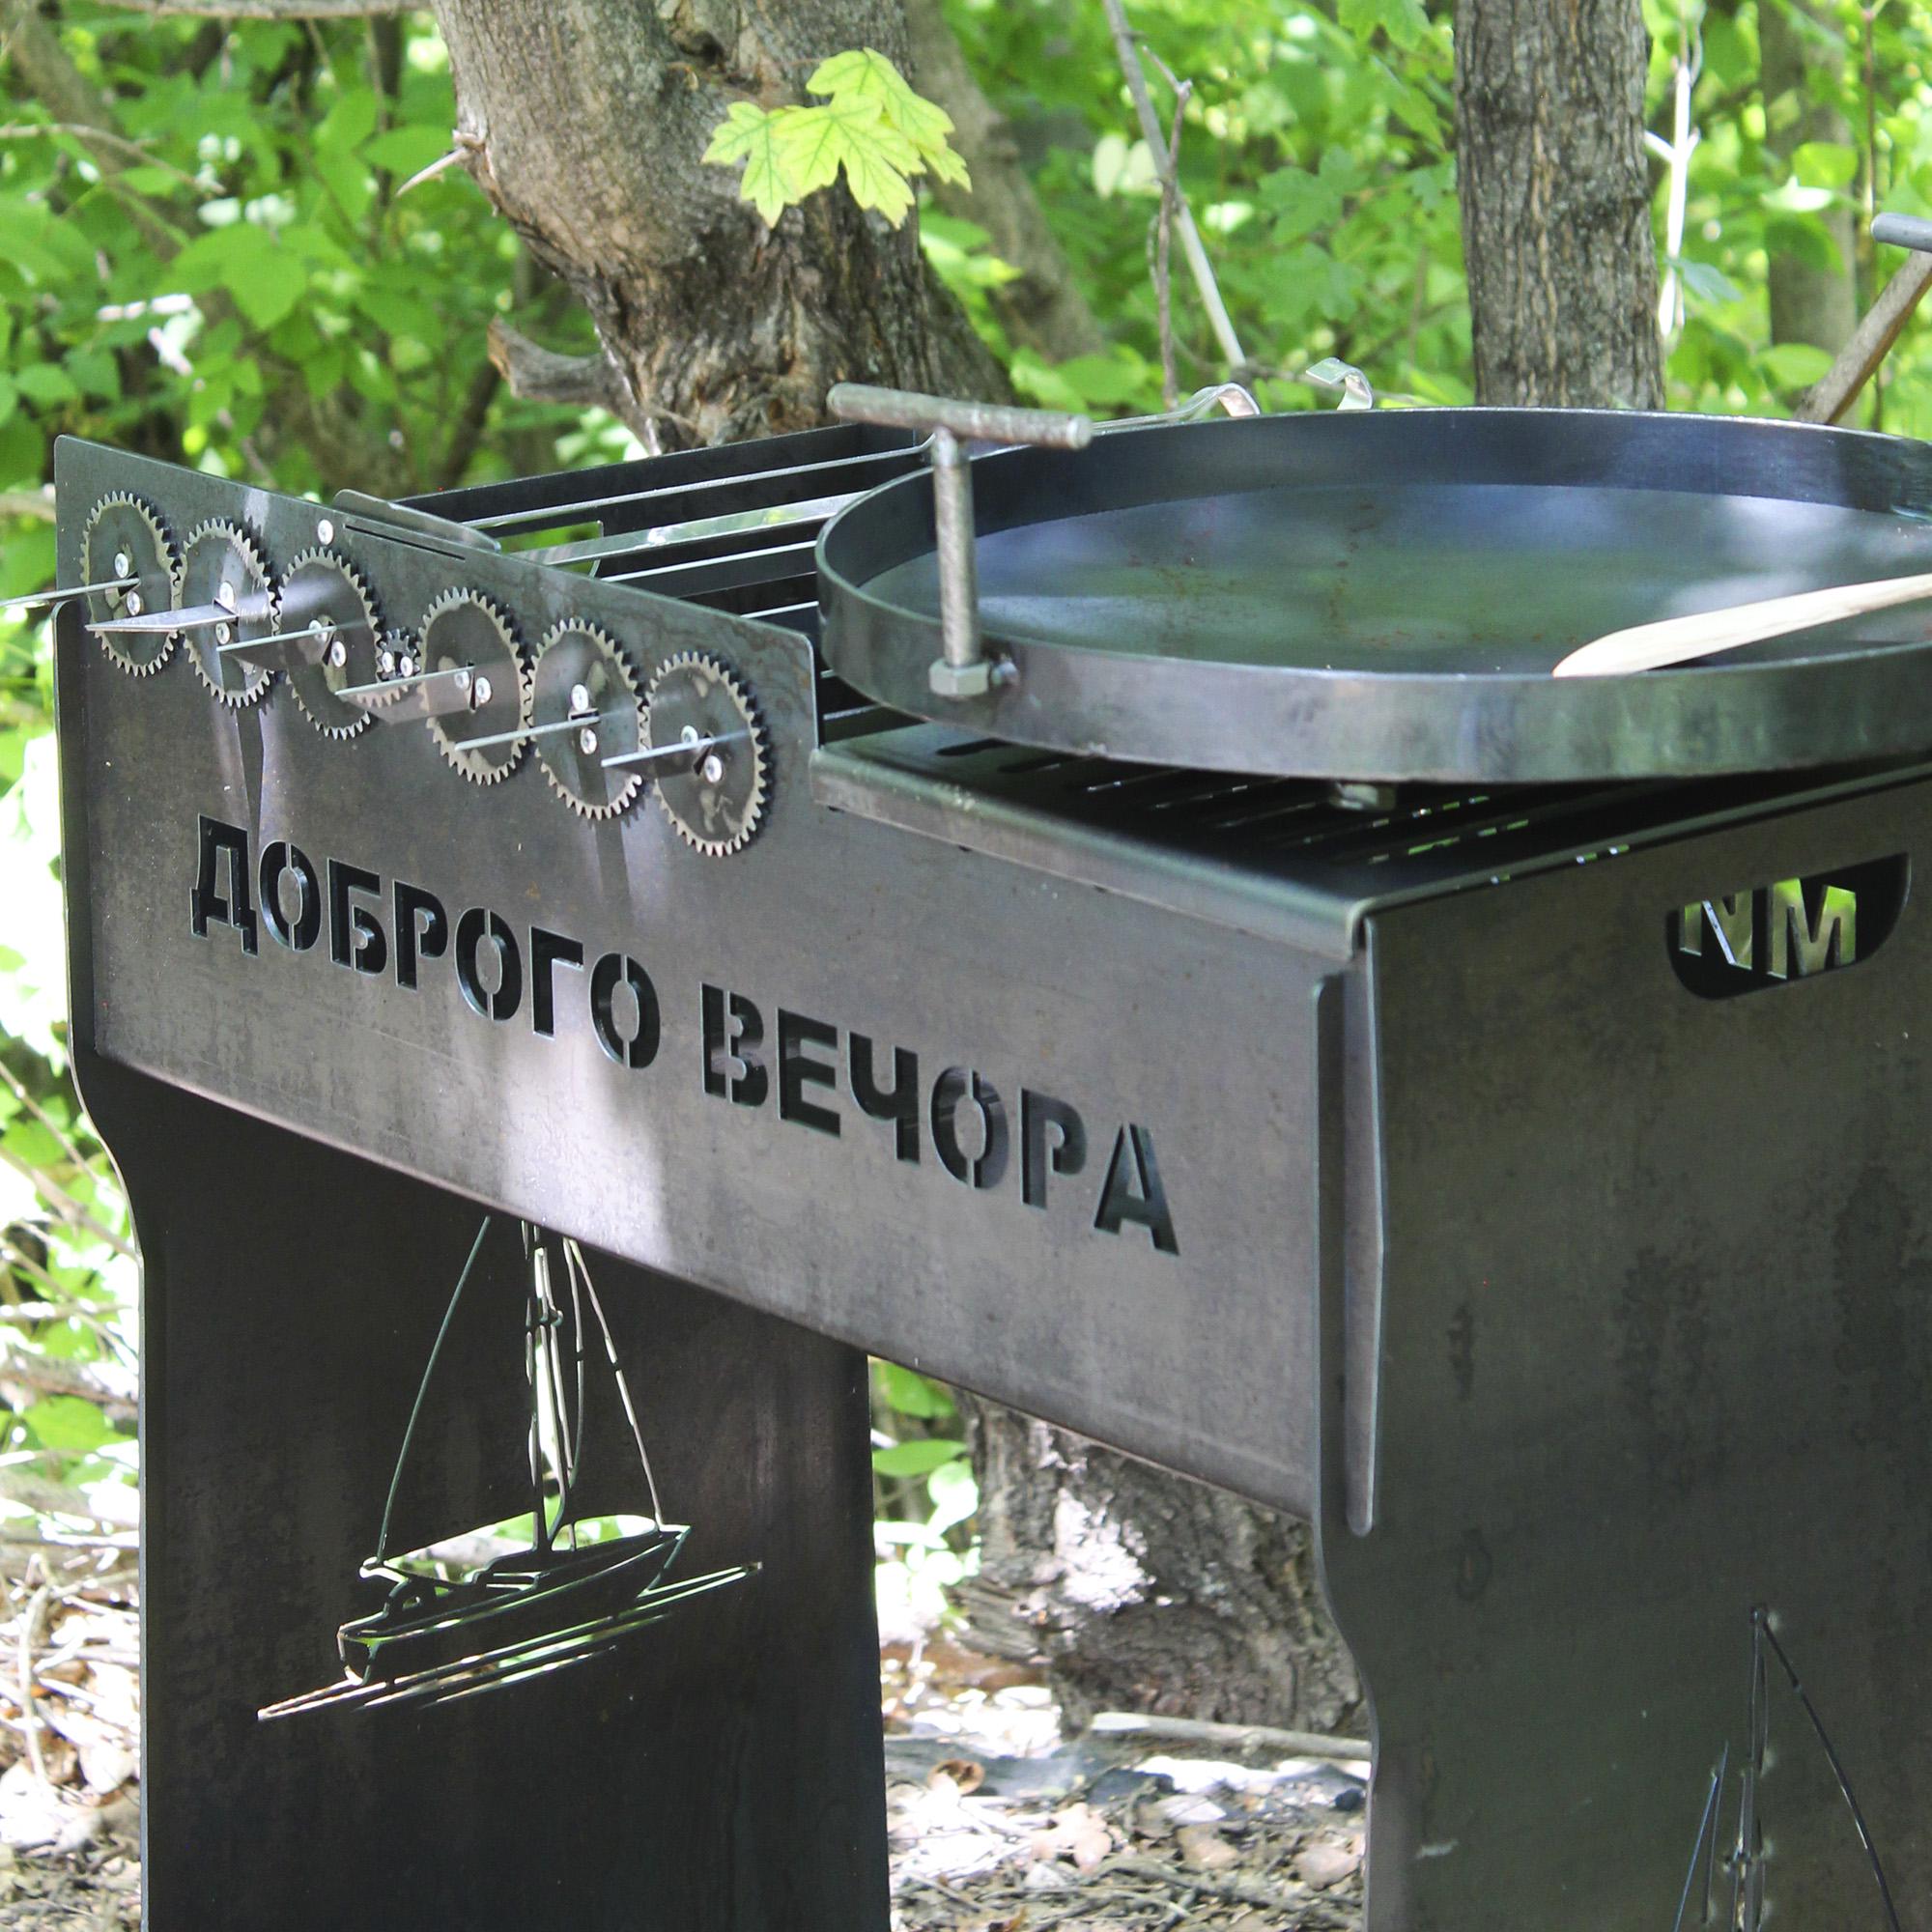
[703, 46, 968, 228]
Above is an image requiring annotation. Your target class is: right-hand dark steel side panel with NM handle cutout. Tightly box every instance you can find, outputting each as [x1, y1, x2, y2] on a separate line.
[1323, 786, 1932, 1932]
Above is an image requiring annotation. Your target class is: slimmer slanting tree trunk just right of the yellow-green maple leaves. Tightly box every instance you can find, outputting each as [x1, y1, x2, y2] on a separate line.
[906, 0, 1107, 361]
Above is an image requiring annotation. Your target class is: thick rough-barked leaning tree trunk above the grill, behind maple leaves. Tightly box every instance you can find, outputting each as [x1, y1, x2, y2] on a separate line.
[423, 0, 1005, 446]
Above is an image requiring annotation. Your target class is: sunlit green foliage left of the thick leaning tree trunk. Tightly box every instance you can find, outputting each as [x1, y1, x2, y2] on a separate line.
[0, 10, 630, 1553]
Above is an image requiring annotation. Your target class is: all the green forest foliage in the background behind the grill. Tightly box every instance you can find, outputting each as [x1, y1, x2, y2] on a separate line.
[0, 0, 1932, 1621]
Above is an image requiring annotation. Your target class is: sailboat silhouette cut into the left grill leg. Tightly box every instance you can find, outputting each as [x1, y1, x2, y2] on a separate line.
[257, 1217, 757, 1719]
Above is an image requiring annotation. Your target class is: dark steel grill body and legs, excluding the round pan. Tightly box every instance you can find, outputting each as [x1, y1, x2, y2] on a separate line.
[42, 423, 1932, 1932]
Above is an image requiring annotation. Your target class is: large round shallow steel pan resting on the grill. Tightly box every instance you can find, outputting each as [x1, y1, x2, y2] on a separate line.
[819, 410, 1932, 784]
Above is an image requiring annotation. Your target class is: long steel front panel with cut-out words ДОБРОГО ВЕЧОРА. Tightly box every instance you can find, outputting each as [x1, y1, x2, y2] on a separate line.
[60, 452, 1333, 1513]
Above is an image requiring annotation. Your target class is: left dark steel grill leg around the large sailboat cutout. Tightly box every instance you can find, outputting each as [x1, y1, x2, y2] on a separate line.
[83, 1063, 887, 1932]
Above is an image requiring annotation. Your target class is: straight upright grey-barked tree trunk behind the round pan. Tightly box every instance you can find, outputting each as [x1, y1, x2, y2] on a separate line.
[1455, 0, 1663, 410]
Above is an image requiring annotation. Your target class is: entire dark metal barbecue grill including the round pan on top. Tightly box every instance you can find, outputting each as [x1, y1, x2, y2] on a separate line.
[42, 396, 1932, 1932]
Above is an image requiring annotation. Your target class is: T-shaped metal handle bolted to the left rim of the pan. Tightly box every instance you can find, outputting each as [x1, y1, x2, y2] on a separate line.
[825, 371, 1275, 697]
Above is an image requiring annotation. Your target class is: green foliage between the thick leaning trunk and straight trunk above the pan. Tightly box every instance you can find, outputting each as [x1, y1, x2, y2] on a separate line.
[937, 0, 1468, 415]
